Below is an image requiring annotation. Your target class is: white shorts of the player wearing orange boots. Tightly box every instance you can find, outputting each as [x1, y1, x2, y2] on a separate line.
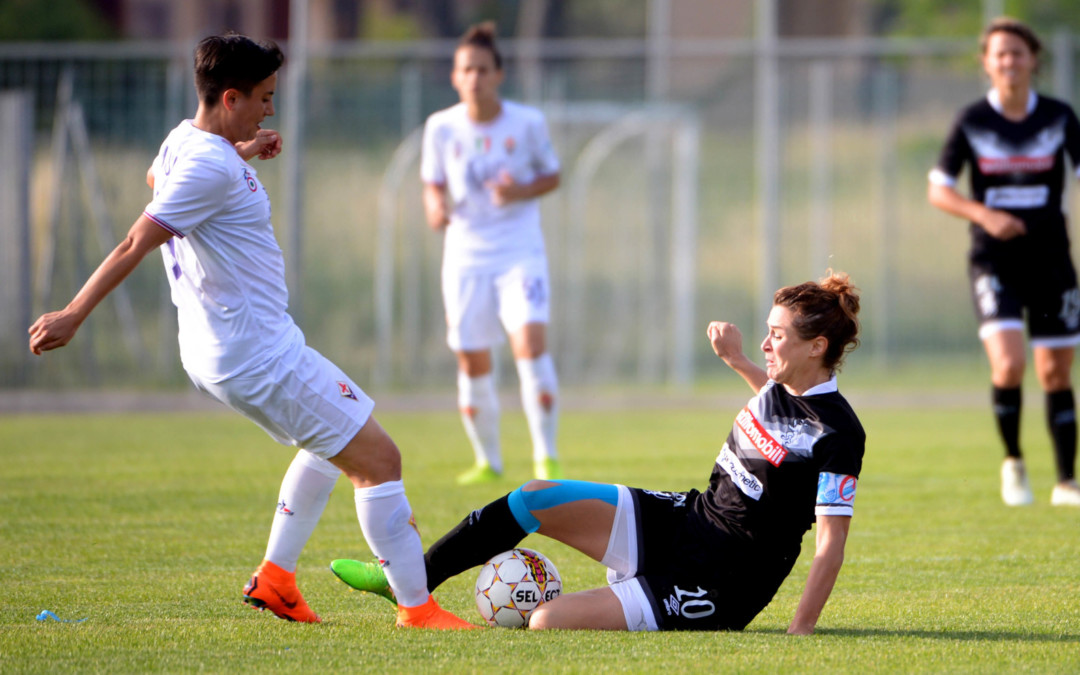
[188, 334, 375, 459]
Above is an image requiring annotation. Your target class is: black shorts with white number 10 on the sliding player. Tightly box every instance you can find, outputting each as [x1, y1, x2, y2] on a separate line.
[630, 488, 798, 631]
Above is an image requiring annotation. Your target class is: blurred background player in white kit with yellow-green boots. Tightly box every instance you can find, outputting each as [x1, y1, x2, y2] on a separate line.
[420, 23, 562, 484]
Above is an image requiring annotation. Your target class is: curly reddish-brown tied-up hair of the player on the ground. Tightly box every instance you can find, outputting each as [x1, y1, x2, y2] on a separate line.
[772, 269, 859, 373]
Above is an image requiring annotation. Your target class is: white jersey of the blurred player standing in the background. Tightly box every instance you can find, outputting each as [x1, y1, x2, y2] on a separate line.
[420, 100, 559, 271]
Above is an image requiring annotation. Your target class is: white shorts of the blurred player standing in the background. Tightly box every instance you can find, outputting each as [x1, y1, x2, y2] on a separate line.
[443, 256, 551, 351]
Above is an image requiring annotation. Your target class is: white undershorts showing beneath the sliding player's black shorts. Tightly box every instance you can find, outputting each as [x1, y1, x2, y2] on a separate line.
[600, 485, 660, 631]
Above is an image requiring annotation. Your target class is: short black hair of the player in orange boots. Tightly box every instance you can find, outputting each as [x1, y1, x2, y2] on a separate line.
[195, 32, 285, 107]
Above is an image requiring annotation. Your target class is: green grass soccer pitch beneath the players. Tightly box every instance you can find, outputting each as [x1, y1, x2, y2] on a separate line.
[0, 405, 1080, 673]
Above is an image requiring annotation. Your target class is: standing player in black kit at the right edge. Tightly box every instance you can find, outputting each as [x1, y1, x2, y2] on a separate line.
[929, 18, 1080, 507]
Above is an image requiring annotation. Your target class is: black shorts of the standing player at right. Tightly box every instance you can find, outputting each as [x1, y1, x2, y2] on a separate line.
[968, 252, 1080, 347]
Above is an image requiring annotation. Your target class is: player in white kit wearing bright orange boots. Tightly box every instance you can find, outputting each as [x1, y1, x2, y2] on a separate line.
[29, 33, 476, 629]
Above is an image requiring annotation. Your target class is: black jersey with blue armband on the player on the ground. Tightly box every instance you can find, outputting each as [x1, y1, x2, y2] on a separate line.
[693, 379, 866, 554]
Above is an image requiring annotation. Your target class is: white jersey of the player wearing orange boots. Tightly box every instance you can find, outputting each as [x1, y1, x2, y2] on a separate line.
[145, 120, 303, 382]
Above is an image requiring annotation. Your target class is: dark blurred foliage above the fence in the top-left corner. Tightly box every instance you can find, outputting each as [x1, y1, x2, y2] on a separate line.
[0, 0, 117, 41]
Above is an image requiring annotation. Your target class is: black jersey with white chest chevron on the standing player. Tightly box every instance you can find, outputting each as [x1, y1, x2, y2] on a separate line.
[936, 93, 1080, 259]
